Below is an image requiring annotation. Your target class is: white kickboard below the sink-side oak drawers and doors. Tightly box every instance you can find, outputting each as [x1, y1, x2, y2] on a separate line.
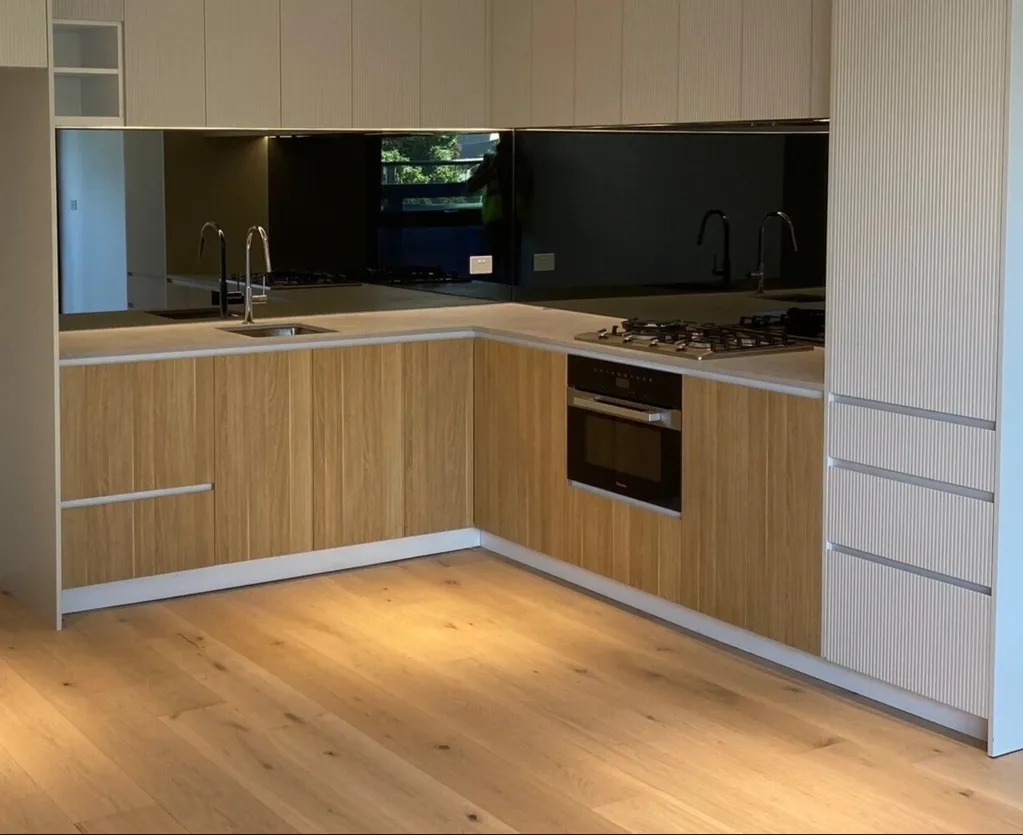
[60, 528, 480, 615]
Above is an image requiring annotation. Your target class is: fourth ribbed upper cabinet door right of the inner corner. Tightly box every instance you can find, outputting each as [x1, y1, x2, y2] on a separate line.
[622, 0, 678, 125]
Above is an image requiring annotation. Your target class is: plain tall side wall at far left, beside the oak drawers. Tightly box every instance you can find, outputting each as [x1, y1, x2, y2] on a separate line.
[0, 70, 60, 627]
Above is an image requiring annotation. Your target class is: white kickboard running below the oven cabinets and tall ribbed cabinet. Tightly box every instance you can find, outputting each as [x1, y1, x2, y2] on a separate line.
[480, 533, 987, 740]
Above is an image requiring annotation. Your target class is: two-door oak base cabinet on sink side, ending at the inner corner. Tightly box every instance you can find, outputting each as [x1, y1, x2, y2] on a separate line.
[312, 340, 474, 548]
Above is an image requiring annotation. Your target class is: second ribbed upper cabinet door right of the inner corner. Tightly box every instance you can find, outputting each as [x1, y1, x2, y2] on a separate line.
[532, 0, 576, 127]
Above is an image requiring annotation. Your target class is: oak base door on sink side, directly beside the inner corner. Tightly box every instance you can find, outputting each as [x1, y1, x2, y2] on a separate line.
[402, 340, 474, 536]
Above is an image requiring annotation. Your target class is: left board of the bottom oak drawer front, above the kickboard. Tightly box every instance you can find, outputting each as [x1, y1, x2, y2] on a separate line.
[60, 501, 135, 588]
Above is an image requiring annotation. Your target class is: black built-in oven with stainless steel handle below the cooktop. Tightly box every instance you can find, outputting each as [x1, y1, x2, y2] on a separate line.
[568, 355, 682, 513]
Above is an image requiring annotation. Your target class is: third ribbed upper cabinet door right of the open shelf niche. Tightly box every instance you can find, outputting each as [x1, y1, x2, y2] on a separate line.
[280, 0, 352, 128]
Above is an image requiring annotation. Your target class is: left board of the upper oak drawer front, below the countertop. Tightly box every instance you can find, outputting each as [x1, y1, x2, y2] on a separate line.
[60, 365, 135, 500]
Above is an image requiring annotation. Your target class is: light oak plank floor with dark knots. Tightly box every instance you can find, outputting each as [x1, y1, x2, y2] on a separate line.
[0, 552, 1023, 833]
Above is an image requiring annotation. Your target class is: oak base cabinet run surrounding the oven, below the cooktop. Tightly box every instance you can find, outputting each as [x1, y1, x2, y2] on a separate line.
[475, 340, 824, 654]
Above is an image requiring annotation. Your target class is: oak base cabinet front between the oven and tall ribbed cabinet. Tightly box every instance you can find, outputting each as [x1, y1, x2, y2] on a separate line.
[682, 378, 824, 654]
